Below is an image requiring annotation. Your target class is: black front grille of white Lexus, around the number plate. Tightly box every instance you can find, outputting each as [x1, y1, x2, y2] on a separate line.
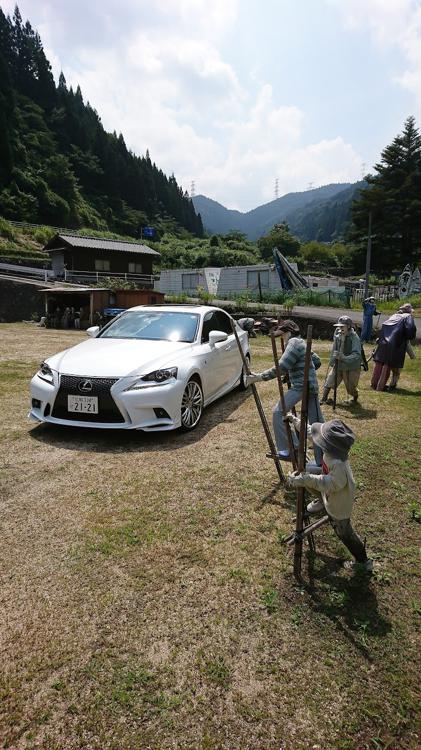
[51, 375, 125, 423]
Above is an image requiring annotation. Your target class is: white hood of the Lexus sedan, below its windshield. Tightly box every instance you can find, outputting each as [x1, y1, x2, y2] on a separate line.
[47, 338, 192, 378]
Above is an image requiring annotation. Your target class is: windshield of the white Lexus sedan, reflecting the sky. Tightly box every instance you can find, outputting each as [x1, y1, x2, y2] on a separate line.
[99, 310, 199, 344]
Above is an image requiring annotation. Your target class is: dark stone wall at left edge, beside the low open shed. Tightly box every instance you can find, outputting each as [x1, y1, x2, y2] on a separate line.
[0, 277, 44, 323]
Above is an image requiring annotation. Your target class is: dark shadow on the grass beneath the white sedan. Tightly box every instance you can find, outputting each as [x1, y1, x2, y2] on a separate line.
[29, 390, 251, 453]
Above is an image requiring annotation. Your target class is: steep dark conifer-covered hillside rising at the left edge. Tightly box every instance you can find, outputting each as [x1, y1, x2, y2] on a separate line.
[0, 8, 203, 236]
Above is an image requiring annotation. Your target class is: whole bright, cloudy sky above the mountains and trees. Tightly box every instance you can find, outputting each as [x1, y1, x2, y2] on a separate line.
[0, 0, 421, 210]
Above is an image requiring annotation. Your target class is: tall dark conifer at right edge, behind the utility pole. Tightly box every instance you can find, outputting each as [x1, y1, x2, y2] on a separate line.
[349, 117, 421, 272]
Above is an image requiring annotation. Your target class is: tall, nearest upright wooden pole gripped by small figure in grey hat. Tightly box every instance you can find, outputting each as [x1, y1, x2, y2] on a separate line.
[294, 326, 313, 582]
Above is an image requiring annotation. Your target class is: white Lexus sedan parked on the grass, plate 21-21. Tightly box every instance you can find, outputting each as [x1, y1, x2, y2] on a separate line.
[29, 305, 250, 431]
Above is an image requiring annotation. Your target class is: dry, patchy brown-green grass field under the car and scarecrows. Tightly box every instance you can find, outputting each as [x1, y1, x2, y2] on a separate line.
[0, 324, 421, 750]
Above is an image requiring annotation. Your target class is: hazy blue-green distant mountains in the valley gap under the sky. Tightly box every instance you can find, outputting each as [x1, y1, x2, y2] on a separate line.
[193, 183, 364, 242]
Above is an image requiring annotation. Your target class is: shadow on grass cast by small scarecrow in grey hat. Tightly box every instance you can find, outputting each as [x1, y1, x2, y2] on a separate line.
[305, 553, 392, 661]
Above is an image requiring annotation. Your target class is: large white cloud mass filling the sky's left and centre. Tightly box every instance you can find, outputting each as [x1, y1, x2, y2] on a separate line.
[2, 0, 364, 210]
